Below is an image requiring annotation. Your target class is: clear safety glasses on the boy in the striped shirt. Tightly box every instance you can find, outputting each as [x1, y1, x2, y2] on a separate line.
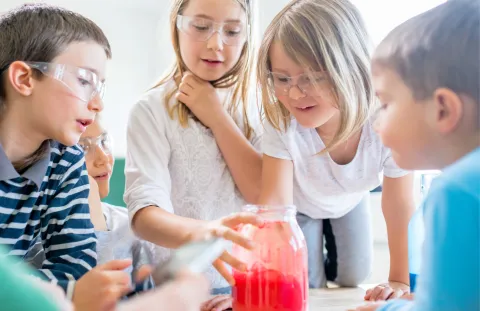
[25, 62, 105, 103]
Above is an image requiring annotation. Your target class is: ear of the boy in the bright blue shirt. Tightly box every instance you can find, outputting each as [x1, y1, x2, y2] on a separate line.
[433, 88, 463, 134]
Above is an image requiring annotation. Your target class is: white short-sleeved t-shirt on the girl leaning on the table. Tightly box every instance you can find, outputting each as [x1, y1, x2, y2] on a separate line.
[262, 118, 408, 219]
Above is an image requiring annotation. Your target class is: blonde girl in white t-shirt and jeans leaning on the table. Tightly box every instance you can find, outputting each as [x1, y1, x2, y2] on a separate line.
[257, 0, 414, 300]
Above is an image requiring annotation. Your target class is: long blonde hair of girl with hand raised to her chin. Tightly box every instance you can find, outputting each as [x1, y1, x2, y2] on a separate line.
[154, 0, 254, 138]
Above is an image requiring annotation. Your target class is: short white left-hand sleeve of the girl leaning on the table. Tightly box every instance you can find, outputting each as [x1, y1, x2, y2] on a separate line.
[262, 120, 292, 160]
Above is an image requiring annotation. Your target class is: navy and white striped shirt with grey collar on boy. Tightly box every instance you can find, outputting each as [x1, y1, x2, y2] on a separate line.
[0, 142, 97, 298]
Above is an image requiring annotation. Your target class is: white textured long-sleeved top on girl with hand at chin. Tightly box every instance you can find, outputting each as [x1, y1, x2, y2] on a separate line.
[124, 81, 263, 288]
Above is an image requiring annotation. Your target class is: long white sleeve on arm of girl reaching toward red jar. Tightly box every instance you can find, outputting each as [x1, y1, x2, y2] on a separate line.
[124, 96, 174, 220]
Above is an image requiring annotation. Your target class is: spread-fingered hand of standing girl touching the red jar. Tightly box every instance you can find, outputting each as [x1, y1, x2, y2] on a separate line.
[188, 213, 263, 285]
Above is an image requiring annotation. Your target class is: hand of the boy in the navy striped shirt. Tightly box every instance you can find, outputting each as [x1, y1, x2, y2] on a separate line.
[73, 259, 132, 311]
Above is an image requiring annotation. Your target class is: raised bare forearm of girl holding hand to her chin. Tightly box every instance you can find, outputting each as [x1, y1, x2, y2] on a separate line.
[212, 116, 262, 203]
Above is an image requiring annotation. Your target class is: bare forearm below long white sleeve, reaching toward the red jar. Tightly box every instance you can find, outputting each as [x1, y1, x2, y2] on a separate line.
[132, 206, 205, 248]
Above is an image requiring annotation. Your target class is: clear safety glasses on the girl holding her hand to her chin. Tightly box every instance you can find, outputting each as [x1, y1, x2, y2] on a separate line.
[177, 15, 247, 45]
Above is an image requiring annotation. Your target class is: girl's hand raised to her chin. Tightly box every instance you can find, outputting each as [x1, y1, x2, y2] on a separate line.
[176, 72, 227, 129]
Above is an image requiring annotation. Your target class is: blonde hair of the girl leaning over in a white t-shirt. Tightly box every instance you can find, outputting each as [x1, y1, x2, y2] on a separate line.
[257, 0, 375, 153]
